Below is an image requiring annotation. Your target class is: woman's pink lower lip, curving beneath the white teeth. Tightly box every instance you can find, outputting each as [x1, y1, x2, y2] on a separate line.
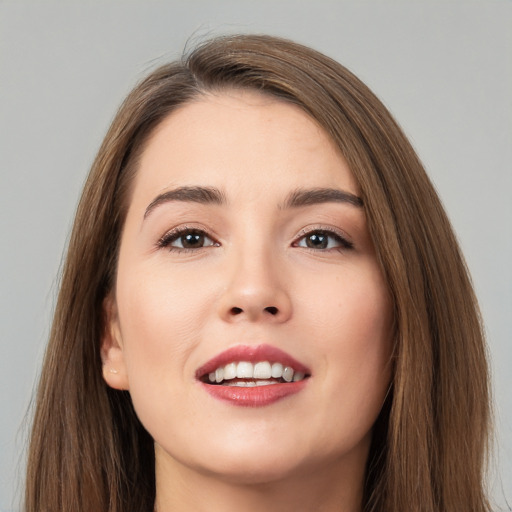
[201, 379, 307, 407]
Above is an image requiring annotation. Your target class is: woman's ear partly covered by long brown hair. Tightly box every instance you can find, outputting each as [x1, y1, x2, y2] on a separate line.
[100, 294, 130, 390]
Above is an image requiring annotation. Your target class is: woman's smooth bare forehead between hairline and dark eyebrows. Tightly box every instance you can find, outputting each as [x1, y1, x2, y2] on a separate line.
[130, 90, 358, 205]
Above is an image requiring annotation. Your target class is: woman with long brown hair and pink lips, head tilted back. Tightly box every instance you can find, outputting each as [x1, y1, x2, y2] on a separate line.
[26, 36, 489, 512]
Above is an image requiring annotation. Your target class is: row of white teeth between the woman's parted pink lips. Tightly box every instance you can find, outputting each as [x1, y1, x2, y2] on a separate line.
[208, 361, 305, 387]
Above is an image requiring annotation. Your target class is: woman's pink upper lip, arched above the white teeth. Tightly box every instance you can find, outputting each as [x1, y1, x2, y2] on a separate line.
[196, 344, 311, 379]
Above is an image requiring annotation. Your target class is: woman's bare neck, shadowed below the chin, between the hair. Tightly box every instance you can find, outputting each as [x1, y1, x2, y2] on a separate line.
[155, 446, 365, 512]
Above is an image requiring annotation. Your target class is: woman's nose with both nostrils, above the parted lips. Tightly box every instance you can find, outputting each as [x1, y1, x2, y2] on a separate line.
[220, 245, 292, 323]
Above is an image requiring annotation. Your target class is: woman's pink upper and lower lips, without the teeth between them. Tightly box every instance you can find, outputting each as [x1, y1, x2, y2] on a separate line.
[196, 345, 311, 407]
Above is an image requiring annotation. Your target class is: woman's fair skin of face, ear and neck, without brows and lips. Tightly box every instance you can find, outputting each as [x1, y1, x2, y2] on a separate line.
[102, 91, 392, 512]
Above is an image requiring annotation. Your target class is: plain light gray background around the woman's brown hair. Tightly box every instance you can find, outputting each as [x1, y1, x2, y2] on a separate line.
[0, 0, 512, 510]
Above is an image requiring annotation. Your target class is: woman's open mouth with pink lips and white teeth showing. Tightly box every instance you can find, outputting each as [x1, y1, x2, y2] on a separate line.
[196, 345, 311, 406]
